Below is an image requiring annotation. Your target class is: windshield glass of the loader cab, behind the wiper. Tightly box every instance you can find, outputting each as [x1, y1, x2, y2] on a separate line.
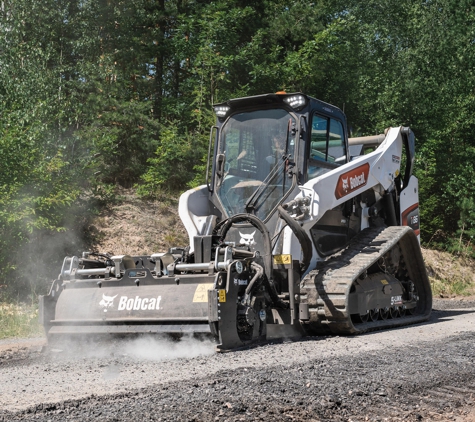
[216, 109, 296, 220]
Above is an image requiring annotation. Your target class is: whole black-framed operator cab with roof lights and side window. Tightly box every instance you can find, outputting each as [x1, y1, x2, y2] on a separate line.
[208, 93, 348, 251]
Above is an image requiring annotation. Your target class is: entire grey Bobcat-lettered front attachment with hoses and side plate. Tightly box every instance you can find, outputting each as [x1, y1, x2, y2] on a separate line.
[40, 236, 278, 350]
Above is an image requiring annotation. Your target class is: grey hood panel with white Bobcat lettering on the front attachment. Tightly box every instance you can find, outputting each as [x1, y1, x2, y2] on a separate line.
[40, 268, 217, 338]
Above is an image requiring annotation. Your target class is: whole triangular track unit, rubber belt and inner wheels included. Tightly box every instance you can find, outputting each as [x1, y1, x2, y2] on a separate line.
[300, 226, 432, 334]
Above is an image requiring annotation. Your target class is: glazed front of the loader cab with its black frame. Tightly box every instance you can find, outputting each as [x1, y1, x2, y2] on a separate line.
[212, 96, 299, 222]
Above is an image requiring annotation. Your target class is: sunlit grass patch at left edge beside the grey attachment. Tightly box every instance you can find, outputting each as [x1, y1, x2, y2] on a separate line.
[0, 302, 44, 339]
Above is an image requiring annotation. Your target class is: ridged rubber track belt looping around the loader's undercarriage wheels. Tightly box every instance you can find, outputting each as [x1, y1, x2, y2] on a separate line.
[300, 226, 432, 335]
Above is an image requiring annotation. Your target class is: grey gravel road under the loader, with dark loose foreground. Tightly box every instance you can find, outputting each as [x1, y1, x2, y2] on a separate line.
[0, 300, 475, 422]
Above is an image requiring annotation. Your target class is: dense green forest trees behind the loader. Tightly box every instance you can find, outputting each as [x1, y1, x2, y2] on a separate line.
[0, 0, 475, 298]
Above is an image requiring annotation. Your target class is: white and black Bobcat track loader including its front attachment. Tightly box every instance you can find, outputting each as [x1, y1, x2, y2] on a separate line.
[40, 92, 432, 350]
